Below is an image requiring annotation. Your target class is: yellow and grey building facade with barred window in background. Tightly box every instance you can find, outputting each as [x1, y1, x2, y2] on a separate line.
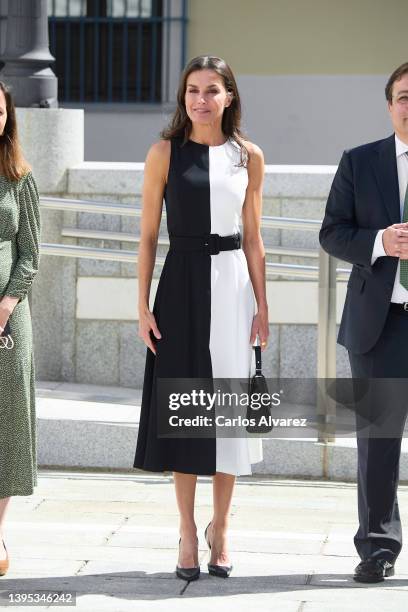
[0, 0, 408, 164]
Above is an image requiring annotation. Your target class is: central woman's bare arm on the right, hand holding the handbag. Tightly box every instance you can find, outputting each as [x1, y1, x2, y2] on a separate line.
[242, 143, 269, 349]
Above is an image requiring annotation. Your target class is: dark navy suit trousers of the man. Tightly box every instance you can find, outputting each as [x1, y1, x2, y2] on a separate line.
[349, 310, 408, 561]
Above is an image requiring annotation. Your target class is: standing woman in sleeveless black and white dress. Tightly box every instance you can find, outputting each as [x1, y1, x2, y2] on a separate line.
[134, 56, 269, 580]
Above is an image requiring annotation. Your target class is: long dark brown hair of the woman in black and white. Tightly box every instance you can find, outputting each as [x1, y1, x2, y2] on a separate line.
[160, 55, 249, 166]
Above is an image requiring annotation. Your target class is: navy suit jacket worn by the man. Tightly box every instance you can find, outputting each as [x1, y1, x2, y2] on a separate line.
[319, 135, 401, 354]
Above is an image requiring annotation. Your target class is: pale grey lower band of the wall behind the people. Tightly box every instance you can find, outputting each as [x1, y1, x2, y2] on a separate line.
[79, 75, 392, 164]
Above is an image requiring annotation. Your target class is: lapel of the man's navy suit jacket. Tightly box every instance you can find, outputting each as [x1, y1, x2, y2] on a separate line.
[373, 134, 401, 224]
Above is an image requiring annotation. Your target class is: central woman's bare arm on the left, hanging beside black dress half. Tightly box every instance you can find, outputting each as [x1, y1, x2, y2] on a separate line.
[138, 140, 170, 354]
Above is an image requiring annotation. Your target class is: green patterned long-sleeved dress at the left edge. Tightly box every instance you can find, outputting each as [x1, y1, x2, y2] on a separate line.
[0, 172, 40, 499]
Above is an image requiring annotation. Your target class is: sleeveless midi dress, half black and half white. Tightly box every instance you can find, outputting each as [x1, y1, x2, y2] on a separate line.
[134, 138, 262, 476]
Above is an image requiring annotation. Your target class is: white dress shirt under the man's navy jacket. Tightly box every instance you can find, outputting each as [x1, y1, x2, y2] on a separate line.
[371, 134, 408, 304]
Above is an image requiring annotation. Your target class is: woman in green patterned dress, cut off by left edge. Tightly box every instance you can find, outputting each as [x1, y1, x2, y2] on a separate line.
[0, 81, 40, 575]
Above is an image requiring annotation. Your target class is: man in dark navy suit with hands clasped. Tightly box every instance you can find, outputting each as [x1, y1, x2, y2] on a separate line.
[319, 62, 408, 582]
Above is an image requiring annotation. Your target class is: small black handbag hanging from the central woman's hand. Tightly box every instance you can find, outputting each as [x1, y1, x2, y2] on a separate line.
[246, 346, 273, 434]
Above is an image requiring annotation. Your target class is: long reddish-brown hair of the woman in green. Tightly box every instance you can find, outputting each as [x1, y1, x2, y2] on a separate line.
[0, 81, 31, 181]
